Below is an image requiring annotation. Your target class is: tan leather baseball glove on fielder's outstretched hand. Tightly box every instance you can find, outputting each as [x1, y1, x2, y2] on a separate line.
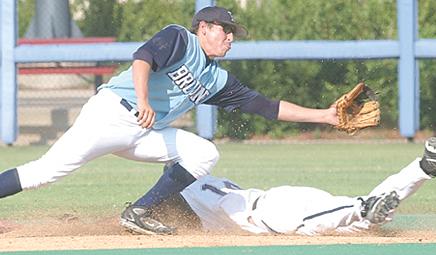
[335, 82, 380, 135]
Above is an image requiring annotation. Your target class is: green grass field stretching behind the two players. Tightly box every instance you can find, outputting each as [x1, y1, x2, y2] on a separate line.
[0, 143, 436, 220]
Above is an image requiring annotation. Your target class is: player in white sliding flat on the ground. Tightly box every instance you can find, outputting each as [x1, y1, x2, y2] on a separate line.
[173, 137, 436, 235]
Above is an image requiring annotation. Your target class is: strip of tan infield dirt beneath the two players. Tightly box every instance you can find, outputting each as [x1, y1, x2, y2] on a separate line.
[0, 215, 436, 251]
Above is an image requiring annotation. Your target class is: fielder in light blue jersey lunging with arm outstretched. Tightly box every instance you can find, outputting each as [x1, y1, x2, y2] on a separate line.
[0, 7, 338, 234]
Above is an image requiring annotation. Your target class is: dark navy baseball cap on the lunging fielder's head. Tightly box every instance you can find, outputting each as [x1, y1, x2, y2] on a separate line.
[192, 6, 248, 38]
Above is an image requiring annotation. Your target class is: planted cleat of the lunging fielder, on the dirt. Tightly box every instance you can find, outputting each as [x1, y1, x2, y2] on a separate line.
[120, 204, 176, 235]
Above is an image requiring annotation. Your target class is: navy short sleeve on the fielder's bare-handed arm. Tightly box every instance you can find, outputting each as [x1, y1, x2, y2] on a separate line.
[133, 25, 188, 71]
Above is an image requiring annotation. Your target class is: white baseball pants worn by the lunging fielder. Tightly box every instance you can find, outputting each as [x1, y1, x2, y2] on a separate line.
[17, 89, 219, 189]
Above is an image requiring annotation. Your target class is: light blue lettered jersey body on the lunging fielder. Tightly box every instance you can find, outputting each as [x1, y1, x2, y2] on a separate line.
[99, 25, 228, 129]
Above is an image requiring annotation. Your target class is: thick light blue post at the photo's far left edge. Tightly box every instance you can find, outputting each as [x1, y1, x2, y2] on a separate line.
[0, 0, 17, 144]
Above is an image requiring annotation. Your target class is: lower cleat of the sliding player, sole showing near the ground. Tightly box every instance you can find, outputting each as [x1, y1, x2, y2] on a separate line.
[360, 191, 400, 224]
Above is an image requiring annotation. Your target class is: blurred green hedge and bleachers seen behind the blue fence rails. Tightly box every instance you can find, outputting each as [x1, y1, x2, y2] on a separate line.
[11, 0, 436, 145]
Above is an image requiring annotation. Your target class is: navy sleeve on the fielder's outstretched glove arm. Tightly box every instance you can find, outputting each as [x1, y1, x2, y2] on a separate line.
[205, 73, 279, 120]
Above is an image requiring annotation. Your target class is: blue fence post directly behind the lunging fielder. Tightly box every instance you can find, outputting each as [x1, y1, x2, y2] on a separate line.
[195, 0, 217, 140]
